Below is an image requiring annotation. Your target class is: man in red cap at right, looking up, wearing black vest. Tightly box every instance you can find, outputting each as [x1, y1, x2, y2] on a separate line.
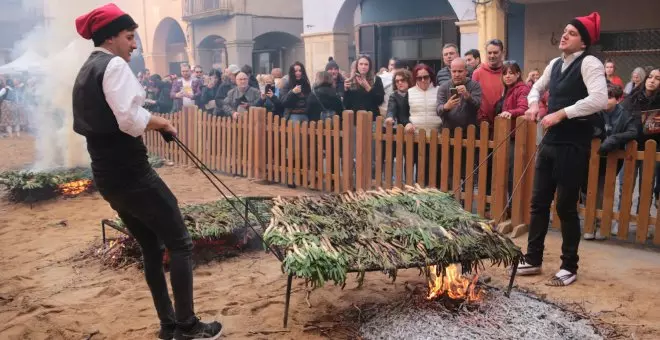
[518, 12, 607, 286]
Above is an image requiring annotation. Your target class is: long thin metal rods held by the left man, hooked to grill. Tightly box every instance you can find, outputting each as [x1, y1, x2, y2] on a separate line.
[159, 131, 284, 262]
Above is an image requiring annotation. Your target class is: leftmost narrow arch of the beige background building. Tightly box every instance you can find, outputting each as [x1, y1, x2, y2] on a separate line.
[153, 18, 188, 74]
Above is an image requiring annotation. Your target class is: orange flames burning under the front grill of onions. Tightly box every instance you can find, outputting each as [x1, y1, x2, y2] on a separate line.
[427, 264, 483, 302]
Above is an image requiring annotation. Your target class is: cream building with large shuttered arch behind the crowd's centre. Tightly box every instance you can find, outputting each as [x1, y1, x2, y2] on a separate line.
[303, 0, 490, 71]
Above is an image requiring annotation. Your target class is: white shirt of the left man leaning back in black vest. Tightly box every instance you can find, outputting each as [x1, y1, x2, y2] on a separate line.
[94, 47, 151, 137]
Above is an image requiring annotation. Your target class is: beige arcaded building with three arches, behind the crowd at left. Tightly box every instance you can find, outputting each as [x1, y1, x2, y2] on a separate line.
[69, 0, 304, 75]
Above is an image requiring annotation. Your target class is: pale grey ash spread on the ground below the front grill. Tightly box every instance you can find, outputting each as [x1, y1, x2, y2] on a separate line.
[360, 291, 603, 340]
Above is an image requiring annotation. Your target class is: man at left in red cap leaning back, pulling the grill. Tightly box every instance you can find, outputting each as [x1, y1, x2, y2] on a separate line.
[73, 4, 222, 340]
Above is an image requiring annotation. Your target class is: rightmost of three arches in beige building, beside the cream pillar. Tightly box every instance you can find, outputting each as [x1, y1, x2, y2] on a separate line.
[252, 32, 305, 74]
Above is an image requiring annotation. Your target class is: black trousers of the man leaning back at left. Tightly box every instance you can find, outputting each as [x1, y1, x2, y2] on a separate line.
[99, 170, 195, 326]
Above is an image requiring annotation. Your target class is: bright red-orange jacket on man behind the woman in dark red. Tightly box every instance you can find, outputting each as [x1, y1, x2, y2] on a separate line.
[472, 63, 504, 129]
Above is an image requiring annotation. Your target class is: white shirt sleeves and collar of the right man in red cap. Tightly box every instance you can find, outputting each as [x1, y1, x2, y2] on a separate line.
[527, 51, 607, 119]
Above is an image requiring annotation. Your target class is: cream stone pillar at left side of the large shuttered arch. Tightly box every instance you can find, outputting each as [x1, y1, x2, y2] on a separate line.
[302, 32, 350, 74]
